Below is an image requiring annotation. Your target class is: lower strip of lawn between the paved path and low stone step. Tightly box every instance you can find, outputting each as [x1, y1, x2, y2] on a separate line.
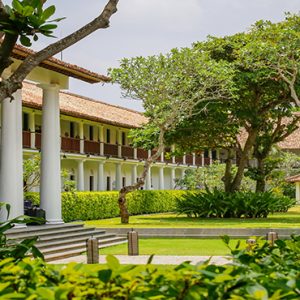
[100, 238, 246, 256]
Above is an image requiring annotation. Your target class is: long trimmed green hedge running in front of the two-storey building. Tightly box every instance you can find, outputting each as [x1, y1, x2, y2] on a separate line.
[25, 190, 193, 222]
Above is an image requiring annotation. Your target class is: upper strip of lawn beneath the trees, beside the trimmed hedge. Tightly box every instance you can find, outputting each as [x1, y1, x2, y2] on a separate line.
[85, 205, 300, 228]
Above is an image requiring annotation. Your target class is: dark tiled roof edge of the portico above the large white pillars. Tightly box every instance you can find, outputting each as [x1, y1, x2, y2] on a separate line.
[12, 45, 110, 83]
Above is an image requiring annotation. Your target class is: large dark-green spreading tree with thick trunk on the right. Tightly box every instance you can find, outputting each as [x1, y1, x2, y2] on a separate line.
[168, 15, 300, 192]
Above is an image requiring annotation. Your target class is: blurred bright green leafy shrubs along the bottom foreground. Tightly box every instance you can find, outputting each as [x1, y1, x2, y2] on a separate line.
[0, 237, 300, 300]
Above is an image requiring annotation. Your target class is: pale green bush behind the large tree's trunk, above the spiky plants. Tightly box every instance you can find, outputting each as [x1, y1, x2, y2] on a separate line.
[176, 162, 254, 191]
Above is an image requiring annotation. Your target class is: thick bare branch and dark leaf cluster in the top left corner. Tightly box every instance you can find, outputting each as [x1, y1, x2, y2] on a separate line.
[0, 0, 118, 101]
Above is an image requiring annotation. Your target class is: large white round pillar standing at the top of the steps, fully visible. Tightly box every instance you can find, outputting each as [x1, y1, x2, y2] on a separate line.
[40, 84, 63, 224]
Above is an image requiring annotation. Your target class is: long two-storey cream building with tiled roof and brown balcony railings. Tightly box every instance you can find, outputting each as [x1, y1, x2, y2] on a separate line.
[22, 83, 218, 191]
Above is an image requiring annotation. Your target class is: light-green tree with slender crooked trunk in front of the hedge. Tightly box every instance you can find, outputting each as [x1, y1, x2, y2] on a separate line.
[110, 48, 233, 223]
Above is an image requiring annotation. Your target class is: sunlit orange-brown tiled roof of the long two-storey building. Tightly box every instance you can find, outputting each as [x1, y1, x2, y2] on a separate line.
[22, 82, 147, 128]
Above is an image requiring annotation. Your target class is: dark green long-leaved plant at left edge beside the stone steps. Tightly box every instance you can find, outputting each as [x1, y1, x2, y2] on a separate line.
[0, 202, 43, 260]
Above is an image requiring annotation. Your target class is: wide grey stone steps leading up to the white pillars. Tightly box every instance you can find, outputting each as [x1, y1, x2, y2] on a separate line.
[7, 223, 127, 261]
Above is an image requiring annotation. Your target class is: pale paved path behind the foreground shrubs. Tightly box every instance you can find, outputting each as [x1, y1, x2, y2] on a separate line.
[51, 255, 230, 265]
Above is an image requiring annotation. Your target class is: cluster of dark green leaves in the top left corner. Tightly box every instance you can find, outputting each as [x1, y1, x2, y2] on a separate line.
[0, 0, 64, 47]
